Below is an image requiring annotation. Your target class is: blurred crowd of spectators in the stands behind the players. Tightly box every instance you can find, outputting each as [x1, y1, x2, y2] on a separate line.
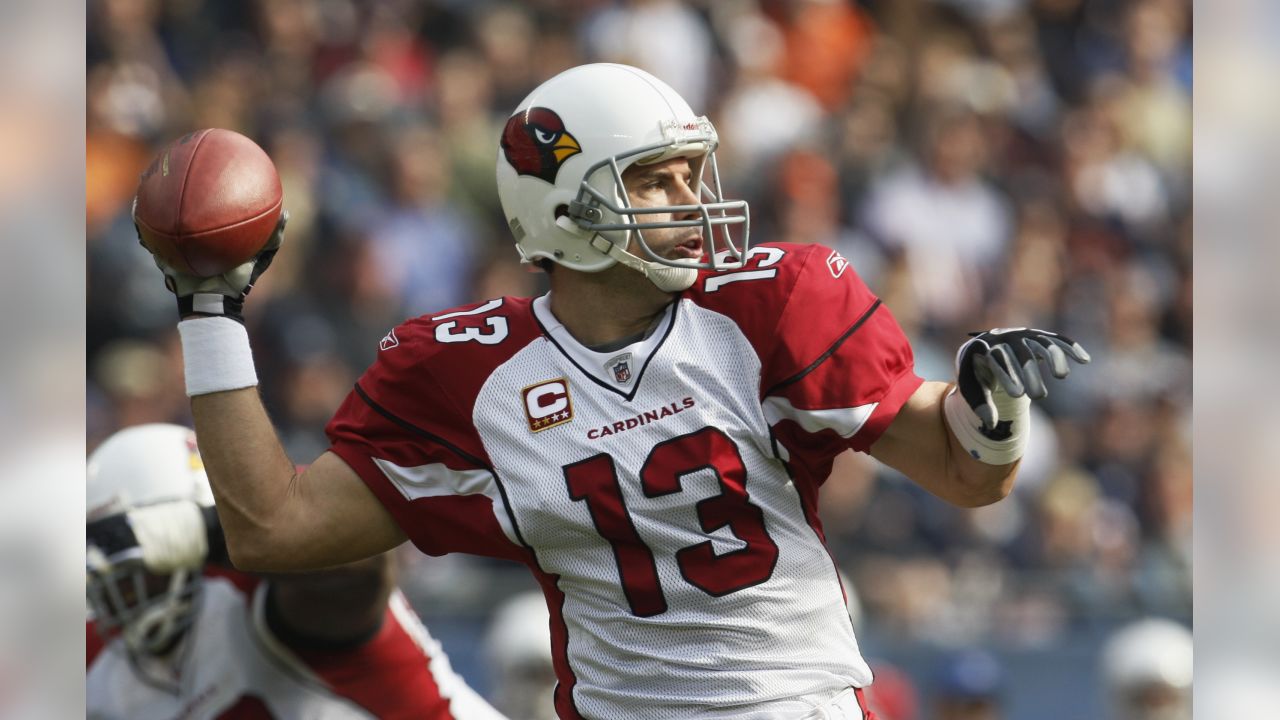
[86, 0, 1192, 720]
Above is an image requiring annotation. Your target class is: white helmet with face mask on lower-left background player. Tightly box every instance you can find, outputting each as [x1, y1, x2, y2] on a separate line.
[86, 423, 214, 655]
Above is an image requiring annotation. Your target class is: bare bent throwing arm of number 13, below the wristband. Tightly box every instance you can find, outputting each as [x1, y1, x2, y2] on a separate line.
[191, 388, 406, 573]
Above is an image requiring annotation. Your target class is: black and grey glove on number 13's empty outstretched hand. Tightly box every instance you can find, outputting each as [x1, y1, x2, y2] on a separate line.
[956, 328, 1089, 441]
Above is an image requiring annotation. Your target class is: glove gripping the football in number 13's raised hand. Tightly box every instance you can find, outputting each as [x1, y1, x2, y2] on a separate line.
[133, 199, 289, 324]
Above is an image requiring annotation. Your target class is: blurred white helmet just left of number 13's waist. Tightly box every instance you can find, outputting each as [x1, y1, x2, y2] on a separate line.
[485, 592, 556, 720]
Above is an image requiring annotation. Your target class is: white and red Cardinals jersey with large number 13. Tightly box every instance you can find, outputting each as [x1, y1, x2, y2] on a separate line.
[328, 245, 922, 720]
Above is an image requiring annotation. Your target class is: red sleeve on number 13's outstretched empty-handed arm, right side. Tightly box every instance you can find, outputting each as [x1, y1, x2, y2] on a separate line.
[695, 243, 924, 476]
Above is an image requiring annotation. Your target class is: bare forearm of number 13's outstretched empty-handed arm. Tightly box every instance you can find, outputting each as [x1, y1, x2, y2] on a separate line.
[870, 382, 1018, 507]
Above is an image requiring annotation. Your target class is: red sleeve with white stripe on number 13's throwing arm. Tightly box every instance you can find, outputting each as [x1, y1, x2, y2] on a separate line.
[325, 301, 532, 561]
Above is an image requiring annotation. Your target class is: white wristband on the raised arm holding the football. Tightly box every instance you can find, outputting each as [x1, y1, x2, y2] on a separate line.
[178, 318, 257, 397]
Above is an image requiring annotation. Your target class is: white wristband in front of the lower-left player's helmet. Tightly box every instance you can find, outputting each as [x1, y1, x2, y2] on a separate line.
[127, 500, 209, 573]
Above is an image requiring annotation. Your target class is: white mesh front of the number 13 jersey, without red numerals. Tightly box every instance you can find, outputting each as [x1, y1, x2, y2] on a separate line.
[472, 301, 870, 719]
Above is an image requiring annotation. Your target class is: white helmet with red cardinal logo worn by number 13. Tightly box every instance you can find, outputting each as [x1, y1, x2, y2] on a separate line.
[498, 63, 749, 292]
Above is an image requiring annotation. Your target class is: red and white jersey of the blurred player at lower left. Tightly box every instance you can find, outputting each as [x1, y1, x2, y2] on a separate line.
[86, 574, 503, 720]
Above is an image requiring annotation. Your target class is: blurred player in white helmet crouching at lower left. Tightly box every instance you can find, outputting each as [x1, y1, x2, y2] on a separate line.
[86, 424, 502, 720]
